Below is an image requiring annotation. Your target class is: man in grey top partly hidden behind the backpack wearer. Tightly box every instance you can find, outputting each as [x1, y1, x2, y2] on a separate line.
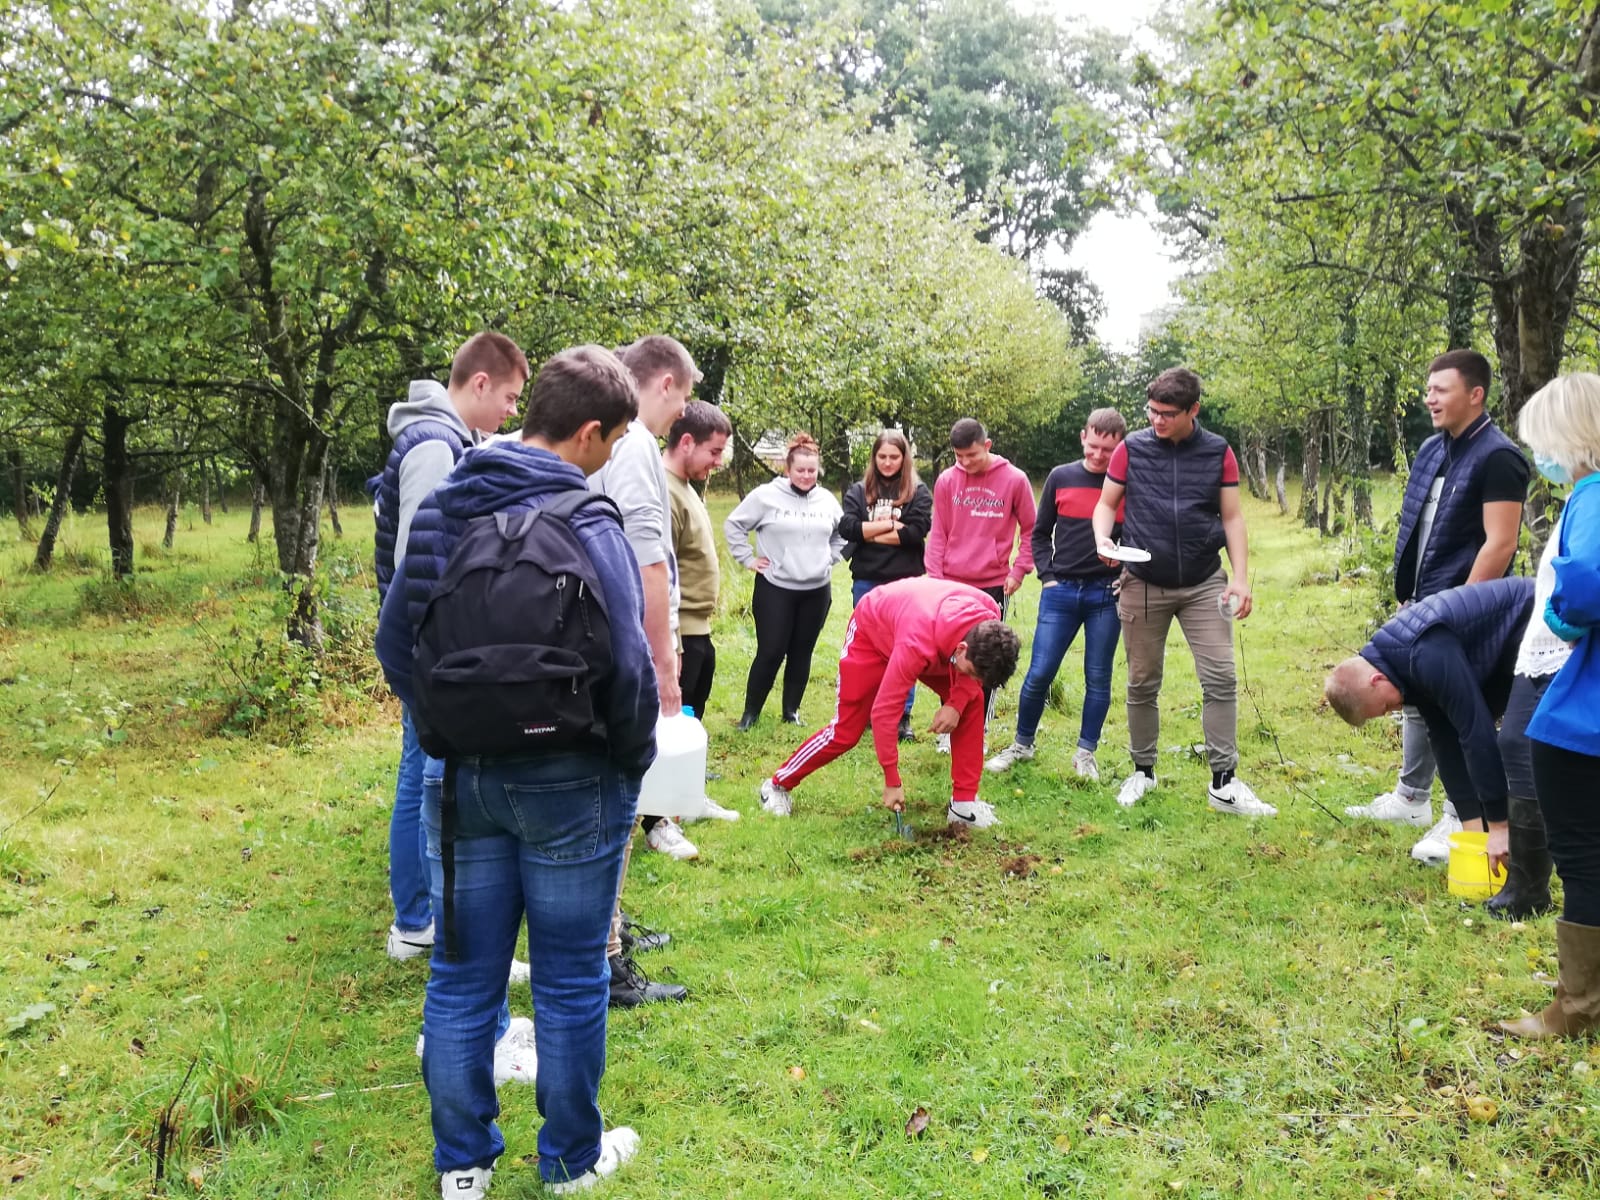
[589, 334, 701, 1008]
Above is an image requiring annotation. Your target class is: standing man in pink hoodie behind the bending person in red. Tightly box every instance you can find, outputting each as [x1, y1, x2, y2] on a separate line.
[923, 416, 1037, 752]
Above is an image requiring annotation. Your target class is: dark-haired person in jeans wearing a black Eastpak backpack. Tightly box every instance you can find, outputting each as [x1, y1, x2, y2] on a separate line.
[378, 346, 659, 1200]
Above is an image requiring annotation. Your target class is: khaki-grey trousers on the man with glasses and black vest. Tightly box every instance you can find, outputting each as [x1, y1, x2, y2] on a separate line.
[1117, 570, 1238, 771]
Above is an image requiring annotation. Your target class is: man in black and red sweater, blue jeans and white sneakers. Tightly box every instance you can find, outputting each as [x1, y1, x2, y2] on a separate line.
[986, 408, 1128, 779]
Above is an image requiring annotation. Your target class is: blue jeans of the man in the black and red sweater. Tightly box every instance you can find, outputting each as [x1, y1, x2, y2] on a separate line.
[1016, 579, 1122, 750]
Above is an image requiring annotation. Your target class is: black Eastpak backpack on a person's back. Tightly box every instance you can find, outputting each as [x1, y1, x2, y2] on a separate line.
[411, 488, 622, 758]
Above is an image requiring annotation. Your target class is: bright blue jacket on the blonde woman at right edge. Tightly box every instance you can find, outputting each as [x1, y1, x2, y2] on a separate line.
[1528, 474, 1600, 757]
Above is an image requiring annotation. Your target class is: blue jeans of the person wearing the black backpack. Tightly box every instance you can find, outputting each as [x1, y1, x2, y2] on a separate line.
[422, 754, 638, 1182]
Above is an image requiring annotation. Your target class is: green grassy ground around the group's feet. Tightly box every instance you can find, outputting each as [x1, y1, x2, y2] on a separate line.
[0, 489, 1600, 1200]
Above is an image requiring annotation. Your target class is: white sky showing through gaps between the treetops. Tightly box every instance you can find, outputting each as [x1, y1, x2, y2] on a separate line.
[1018, 0, 1182, 350]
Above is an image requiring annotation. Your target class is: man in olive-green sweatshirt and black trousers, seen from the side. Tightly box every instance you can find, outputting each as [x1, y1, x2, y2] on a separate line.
[640, 400, 739, 859]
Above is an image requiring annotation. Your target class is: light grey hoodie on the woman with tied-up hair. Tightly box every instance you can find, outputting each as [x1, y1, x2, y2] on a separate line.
[722, 478, 845, 592]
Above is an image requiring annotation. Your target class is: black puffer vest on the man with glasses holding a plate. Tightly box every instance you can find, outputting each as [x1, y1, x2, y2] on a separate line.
[1122, 422, 1227, 587]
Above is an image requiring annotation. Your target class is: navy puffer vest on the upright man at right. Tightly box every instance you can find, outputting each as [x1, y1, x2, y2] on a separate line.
[1395, 413, 1522, 602]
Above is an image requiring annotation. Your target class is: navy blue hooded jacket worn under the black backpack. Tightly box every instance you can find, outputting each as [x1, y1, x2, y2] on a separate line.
[378, 440, 659, 776]
